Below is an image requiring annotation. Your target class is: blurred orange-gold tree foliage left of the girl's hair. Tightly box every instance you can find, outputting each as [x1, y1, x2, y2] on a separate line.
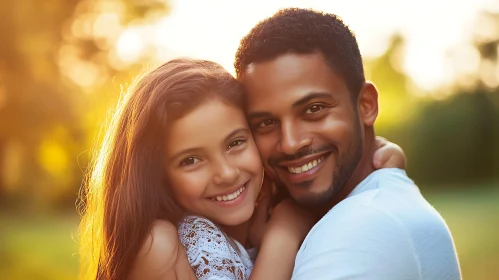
[0, 0, 168, 210]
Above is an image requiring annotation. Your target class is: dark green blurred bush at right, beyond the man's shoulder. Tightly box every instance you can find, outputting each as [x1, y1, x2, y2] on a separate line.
[404, 91, 499, 186]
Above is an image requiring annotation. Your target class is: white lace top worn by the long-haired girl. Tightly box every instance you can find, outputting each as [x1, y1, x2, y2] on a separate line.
[178, 216, 253, 280]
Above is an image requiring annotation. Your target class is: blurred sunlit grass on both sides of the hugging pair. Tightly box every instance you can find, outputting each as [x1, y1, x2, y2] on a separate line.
[0, 185, 499, 280]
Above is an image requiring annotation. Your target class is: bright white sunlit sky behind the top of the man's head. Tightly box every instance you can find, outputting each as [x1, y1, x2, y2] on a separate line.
[112, 0, 499, 91]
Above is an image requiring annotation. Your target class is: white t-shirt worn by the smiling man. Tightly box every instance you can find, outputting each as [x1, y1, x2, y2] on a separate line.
[292, 168, 461, 280]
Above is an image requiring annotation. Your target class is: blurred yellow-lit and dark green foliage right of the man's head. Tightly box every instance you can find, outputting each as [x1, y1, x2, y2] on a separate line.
[366, 34, 499, 186]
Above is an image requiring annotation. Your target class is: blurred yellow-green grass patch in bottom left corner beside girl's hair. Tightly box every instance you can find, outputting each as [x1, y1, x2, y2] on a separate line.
[0, 214, 78, 280]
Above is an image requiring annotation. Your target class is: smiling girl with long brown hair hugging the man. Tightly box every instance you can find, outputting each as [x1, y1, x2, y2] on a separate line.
[80, 59, 404, 279]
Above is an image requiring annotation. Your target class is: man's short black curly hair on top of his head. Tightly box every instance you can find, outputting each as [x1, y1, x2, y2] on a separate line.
[234, 8, 365, 98]
